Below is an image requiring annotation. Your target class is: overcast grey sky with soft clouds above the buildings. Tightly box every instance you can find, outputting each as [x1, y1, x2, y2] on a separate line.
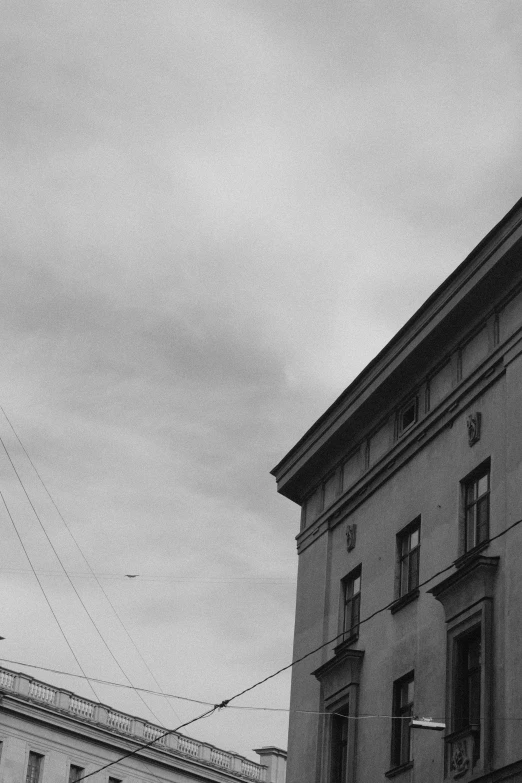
[0, 0, 522, 758]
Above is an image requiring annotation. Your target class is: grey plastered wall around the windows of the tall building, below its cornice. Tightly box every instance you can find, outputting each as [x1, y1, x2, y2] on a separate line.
[276, 207, 522, 783]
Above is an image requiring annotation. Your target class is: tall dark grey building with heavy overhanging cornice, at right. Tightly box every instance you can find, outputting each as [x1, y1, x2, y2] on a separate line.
[273, 201, 522, 783]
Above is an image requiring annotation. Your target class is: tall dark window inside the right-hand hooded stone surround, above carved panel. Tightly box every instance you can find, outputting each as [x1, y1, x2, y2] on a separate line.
[453, 626, 482, 747]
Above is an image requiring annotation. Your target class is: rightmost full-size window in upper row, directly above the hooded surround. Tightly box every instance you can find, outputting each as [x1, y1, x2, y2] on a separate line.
[459, 458, 491, 557]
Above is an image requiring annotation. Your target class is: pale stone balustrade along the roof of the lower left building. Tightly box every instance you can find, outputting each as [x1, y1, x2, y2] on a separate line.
[0, 668, 267, 783]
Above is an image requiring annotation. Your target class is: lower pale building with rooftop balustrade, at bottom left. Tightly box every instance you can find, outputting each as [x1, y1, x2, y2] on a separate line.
[0, 668, 286, 783]
